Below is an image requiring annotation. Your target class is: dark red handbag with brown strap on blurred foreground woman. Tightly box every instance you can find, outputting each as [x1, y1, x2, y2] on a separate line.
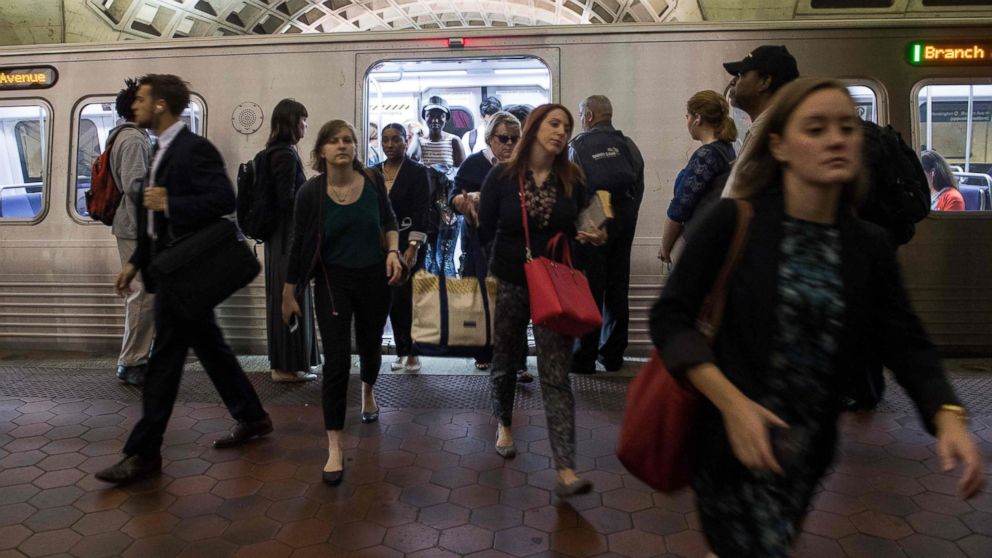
[617, 200, 752, 492]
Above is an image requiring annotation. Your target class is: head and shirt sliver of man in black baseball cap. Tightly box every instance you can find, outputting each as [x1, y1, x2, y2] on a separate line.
[723, 45, 799, 197]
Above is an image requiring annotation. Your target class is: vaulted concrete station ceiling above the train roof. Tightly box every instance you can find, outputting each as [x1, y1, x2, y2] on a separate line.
[0, 0, 992, 45]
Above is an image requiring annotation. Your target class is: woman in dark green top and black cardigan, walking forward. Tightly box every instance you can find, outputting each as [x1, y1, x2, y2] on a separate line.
[282, 120, 403, 485]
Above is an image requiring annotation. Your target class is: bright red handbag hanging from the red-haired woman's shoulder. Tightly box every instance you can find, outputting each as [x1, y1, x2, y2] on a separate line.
[519, 177, 603, 337]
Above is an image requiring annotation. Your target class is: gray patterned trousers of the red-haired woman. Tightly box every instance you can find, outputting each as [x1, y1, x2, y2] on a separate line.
[490, 279, 575, 469]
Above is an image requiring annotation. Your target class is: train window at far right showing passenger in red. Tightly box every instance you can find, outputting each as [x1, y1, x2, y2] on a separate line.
[913, 83, 992, 211]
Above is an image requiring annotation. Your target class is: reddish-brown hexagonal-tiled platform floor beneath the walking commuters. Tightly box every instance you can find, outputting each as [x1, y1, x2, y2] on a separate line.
[0, 351, 992, 558]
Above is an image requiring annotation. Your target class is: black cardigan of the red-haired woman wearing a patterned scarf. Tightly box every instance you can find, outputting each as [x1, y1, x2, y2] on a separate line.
[479, 165, 589, 285]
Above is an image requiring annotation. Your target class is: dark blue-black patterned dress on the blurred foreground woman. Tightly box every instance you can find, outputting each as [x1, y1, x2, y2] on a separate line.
[693, 217, 844, 558]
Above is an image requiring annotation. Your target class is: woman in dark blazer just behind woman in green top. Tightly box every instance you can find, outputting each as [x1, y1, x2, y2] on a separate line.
[373, 123, 431, 372]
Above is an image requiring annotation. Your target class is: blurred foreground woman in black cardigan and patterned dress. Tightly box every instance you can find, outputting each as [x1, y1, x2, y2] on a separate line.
[651, 79, 984, 557]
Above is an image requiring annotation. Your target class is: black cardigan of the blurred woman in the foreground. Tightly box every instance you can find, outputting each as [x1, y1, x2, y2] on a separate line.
[651, 192, 959, 438]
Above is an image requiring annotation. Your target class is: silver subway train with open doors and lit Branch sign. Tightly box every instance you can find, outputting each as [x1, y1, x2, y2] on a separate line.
[0, 18, 992, 356]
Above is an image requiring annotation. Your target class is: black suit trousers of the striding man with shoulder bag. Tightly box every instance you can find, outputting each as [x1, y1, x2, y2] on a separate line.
[124, 292, 266, 458]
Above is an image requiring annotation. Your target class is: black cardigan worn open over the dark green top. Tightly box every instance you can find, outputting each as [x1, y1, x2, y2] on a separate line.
[286, 169, 396, 285]
